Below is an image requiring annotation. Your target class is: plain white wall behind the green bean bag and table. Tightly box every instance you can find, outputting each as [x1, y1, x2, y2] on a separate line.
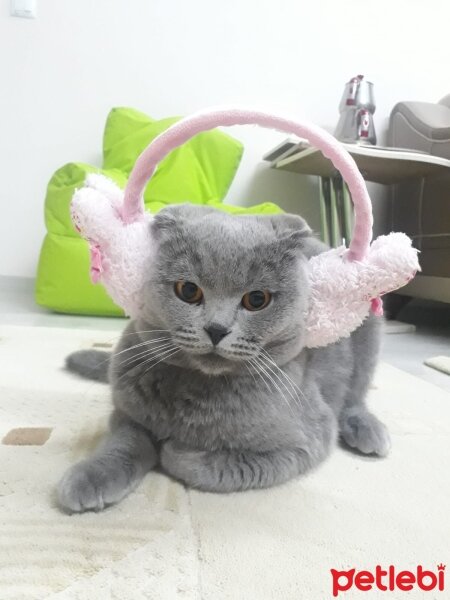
[0, 0, 450, 276]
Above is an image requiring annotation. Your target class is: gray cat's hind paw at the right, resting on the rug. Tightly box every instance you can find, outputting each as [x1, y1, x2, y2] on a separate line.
[341, 410, 391, 456]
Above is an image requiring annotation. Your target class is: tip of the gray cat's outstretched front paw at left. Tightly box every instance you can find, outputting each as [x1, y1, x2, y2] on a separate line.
[57, 460, 130, 513]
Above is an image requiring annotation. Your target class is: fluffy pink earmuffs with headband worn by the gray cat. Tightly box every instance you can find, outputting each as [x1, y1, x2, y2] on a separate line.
[71, 109, 420, 347]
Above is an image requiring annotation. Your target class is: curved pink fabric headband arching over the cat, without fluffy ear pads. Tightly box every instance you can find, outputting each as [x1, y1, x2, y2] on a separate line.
[122, 109, 373, 260]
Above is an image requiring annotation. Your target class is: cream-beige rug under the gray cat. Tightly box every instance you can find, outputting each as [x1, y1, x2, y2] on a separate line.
[0, 327, 450, 600]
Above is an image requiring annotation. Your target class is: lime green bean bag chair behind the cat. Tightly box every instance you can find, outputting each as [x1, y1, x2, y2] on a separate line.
[36, 108, 281, 316]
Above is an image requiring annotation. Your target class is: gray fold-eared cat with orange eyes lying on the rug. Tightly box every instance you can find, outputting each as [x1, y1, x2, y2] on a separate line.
[58, 205, 390, 512]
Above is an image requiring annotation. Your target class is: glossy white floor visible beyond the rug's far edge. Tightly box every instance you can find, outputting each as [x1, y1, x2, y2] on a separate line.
[0, 277, 450, 391]
